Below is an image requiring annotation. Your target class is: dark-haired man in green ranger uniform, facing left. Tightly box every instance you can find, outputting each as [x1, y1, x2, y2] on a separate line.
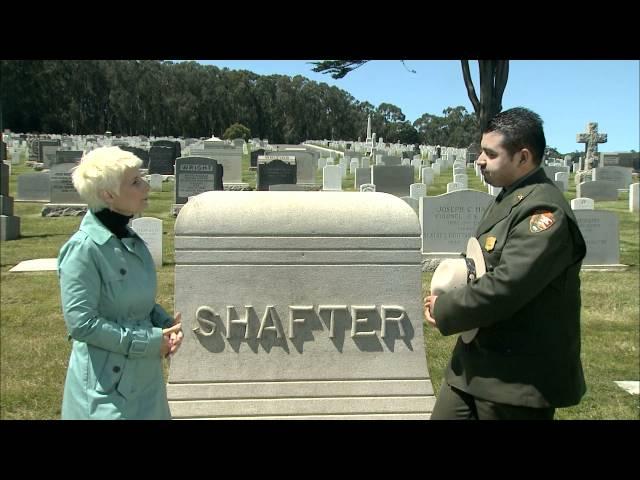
[425, 108, 586, 419]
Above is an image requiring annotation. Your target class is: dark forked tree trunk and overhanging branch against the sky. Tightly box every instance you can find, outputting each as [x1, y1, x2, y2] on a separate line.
[311, 60, 509, 139]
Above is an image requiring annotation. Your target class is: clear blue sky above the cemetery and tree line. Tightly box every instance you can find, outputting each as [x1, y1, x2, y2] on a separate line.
[196, 60, 640, 153]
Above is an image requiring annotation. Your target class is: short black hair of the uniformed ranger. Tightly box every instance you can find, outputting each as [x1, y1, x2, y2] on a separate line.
[482, 107, 547, 165]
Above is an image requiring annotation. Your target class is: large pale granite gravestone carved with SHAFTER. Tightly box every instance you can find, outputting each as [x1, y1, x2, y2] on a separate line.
[167, 192, 435, 419]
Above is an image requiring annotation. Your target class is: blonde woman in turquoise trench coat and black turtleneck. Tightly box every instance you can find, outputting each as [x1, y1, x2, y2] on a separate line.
[58, 147, 183, 419]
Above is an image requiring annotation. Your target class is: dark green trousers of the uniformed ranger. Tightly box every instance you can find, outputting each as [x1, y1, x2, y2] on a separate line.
[431, 380, 556, 420]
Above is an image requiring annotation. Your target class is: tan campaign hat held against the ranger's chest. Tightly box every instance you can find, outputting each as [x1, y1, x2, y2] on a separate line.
[431, 237, 487, 343]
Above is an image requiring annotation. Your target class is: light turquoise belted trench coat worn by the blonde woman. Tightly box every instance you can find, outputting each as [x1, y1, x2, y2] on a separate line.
[58, 211, 173, 419]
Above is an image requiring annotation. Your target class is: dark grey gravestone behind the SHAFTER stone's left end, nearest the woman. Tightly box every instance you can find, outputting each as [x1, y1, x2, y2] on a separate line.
[174, 157, 224, 204]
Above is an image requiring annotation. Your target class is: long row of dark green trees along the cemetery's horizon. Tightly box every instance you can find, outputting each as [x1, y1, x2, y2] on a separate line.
[0, 60, 484, 147]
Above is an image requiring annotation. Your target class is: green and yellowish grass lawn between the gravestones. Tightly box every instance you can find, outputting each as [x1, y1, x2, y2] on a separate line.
[0, 155, 640, 420]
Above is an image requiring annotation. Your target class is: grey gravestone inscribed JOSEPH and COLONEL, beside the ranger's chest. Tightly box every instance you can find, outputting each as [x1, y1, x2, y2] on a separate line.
[418, 190, 494, 258]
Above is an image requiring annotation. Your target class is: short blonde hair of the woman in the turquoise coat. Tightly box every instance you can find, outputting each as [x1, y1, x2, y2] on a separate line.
[71, 147, 142, 211]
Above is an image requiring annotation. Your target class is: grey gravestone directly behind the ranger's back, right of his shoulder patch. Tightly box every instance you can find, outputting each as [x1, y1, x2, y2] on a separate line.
[573, 210, 623, 270]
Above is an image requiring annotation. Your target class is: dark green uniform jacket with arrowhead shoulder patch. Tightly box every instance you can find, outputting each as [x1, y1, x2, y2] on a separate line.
[433, 168, 586, 408]
